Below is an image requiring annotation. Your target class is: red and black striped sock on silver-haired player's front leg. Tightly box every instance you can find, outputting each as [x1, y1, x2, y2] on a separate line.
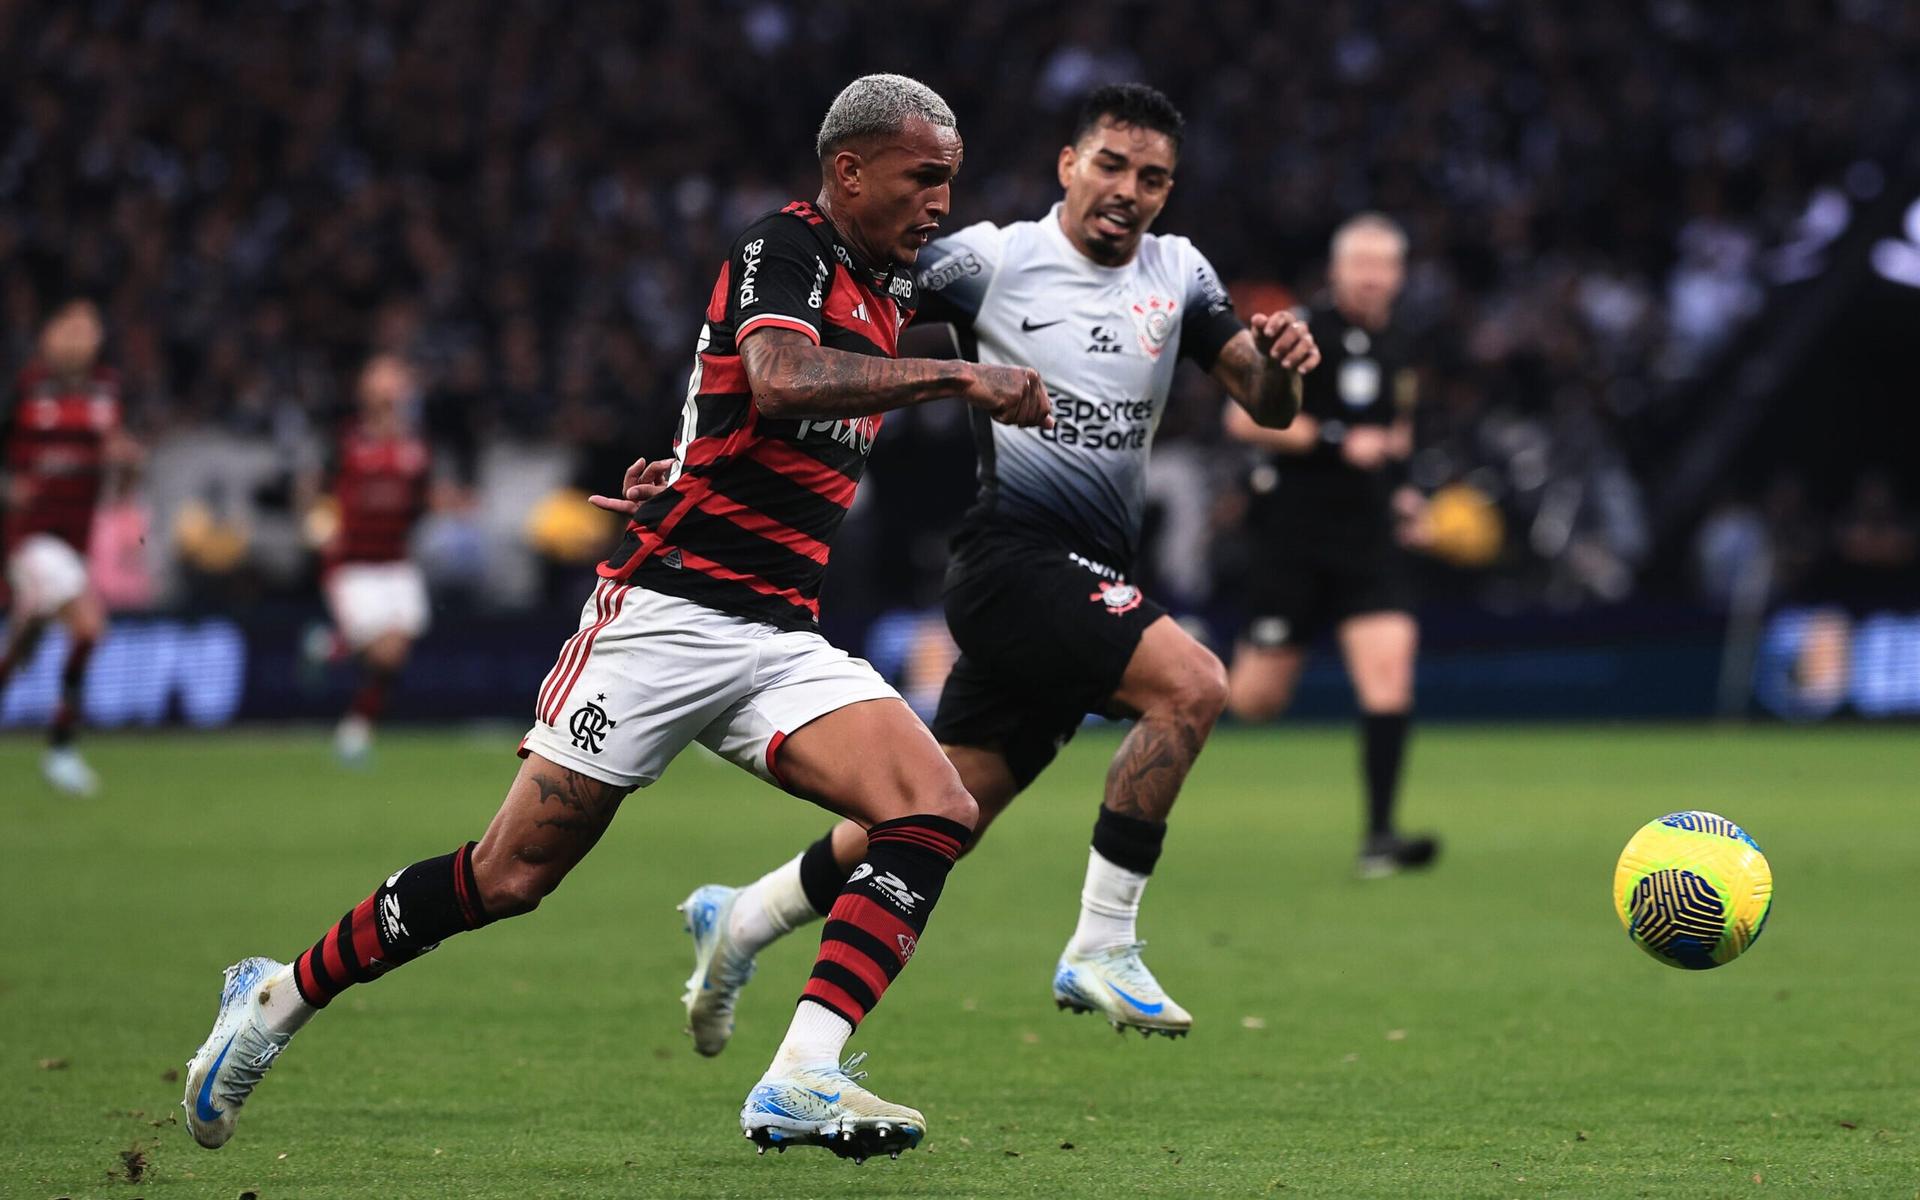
[801, 816, 973, 1027]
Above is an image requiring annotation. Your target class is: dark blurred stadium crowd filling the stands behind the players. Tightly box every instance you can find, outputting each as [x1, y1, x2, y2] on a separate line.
[0, 0, 1920, 603]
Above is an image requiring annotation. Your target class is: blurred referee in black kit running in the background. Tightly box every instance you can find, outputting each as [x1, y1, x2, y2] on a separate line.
[1227, 213, 1440, 877]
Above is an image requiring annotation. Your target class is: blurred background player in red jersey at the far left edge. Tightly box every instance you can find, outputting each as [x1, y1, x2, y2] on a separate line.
[0, 300, 138, 795]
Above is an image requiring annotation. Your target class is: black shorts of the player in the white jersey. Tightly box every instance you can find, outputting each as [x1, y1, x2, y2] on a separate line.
[933, 540, 1167, 787]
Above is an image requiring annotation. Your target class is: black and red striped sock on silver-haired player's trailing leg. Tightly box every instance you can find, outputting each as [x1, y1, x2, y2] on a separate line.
[294, 841, 490, 1008]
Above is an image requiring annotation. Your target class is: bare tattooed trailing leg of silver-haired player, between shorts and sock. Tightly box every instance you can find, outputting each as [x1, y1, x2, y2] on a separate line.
[474, 755, 632, 918]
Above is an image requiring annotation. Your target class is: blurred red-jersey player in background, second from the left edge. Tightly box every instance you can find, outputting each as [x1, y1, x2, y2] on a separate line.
[321, 353, 434, 762]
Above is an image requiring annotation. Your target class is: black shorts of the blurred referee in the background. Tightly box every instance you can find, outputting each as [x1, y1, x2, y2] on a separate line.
[1240, 536, 1413, 647]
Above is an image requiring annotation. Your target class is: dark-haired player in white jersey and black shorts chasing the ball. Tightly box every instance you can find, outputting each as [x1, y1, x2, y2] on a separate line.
[664, 84, 1319, 1054]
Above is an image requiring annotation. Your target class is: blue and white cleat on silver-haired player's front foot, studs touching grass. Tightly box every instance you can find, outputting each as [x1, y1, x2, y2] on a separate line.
[739, 1054, 927, 1164]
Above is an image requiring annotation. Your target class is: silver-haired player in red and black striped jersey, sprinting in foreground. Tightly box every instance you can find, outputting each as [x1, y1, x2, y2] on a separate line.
[184, 75, 1050, 1158]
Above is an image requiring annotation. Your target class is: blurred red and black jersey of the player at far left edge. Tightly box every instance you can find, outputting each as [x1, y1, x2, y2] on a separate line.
[0, 363, 121, 555]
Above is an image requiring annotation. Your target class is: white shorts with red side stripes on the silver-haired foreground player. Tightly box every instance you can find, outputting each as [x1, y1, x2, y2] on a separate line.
[520, 580, 900, 787]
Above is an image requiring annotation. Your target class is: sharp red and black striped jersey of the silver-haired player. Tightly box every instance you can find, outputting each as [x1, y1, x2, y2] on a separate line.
[599, 202, 914, 630]
